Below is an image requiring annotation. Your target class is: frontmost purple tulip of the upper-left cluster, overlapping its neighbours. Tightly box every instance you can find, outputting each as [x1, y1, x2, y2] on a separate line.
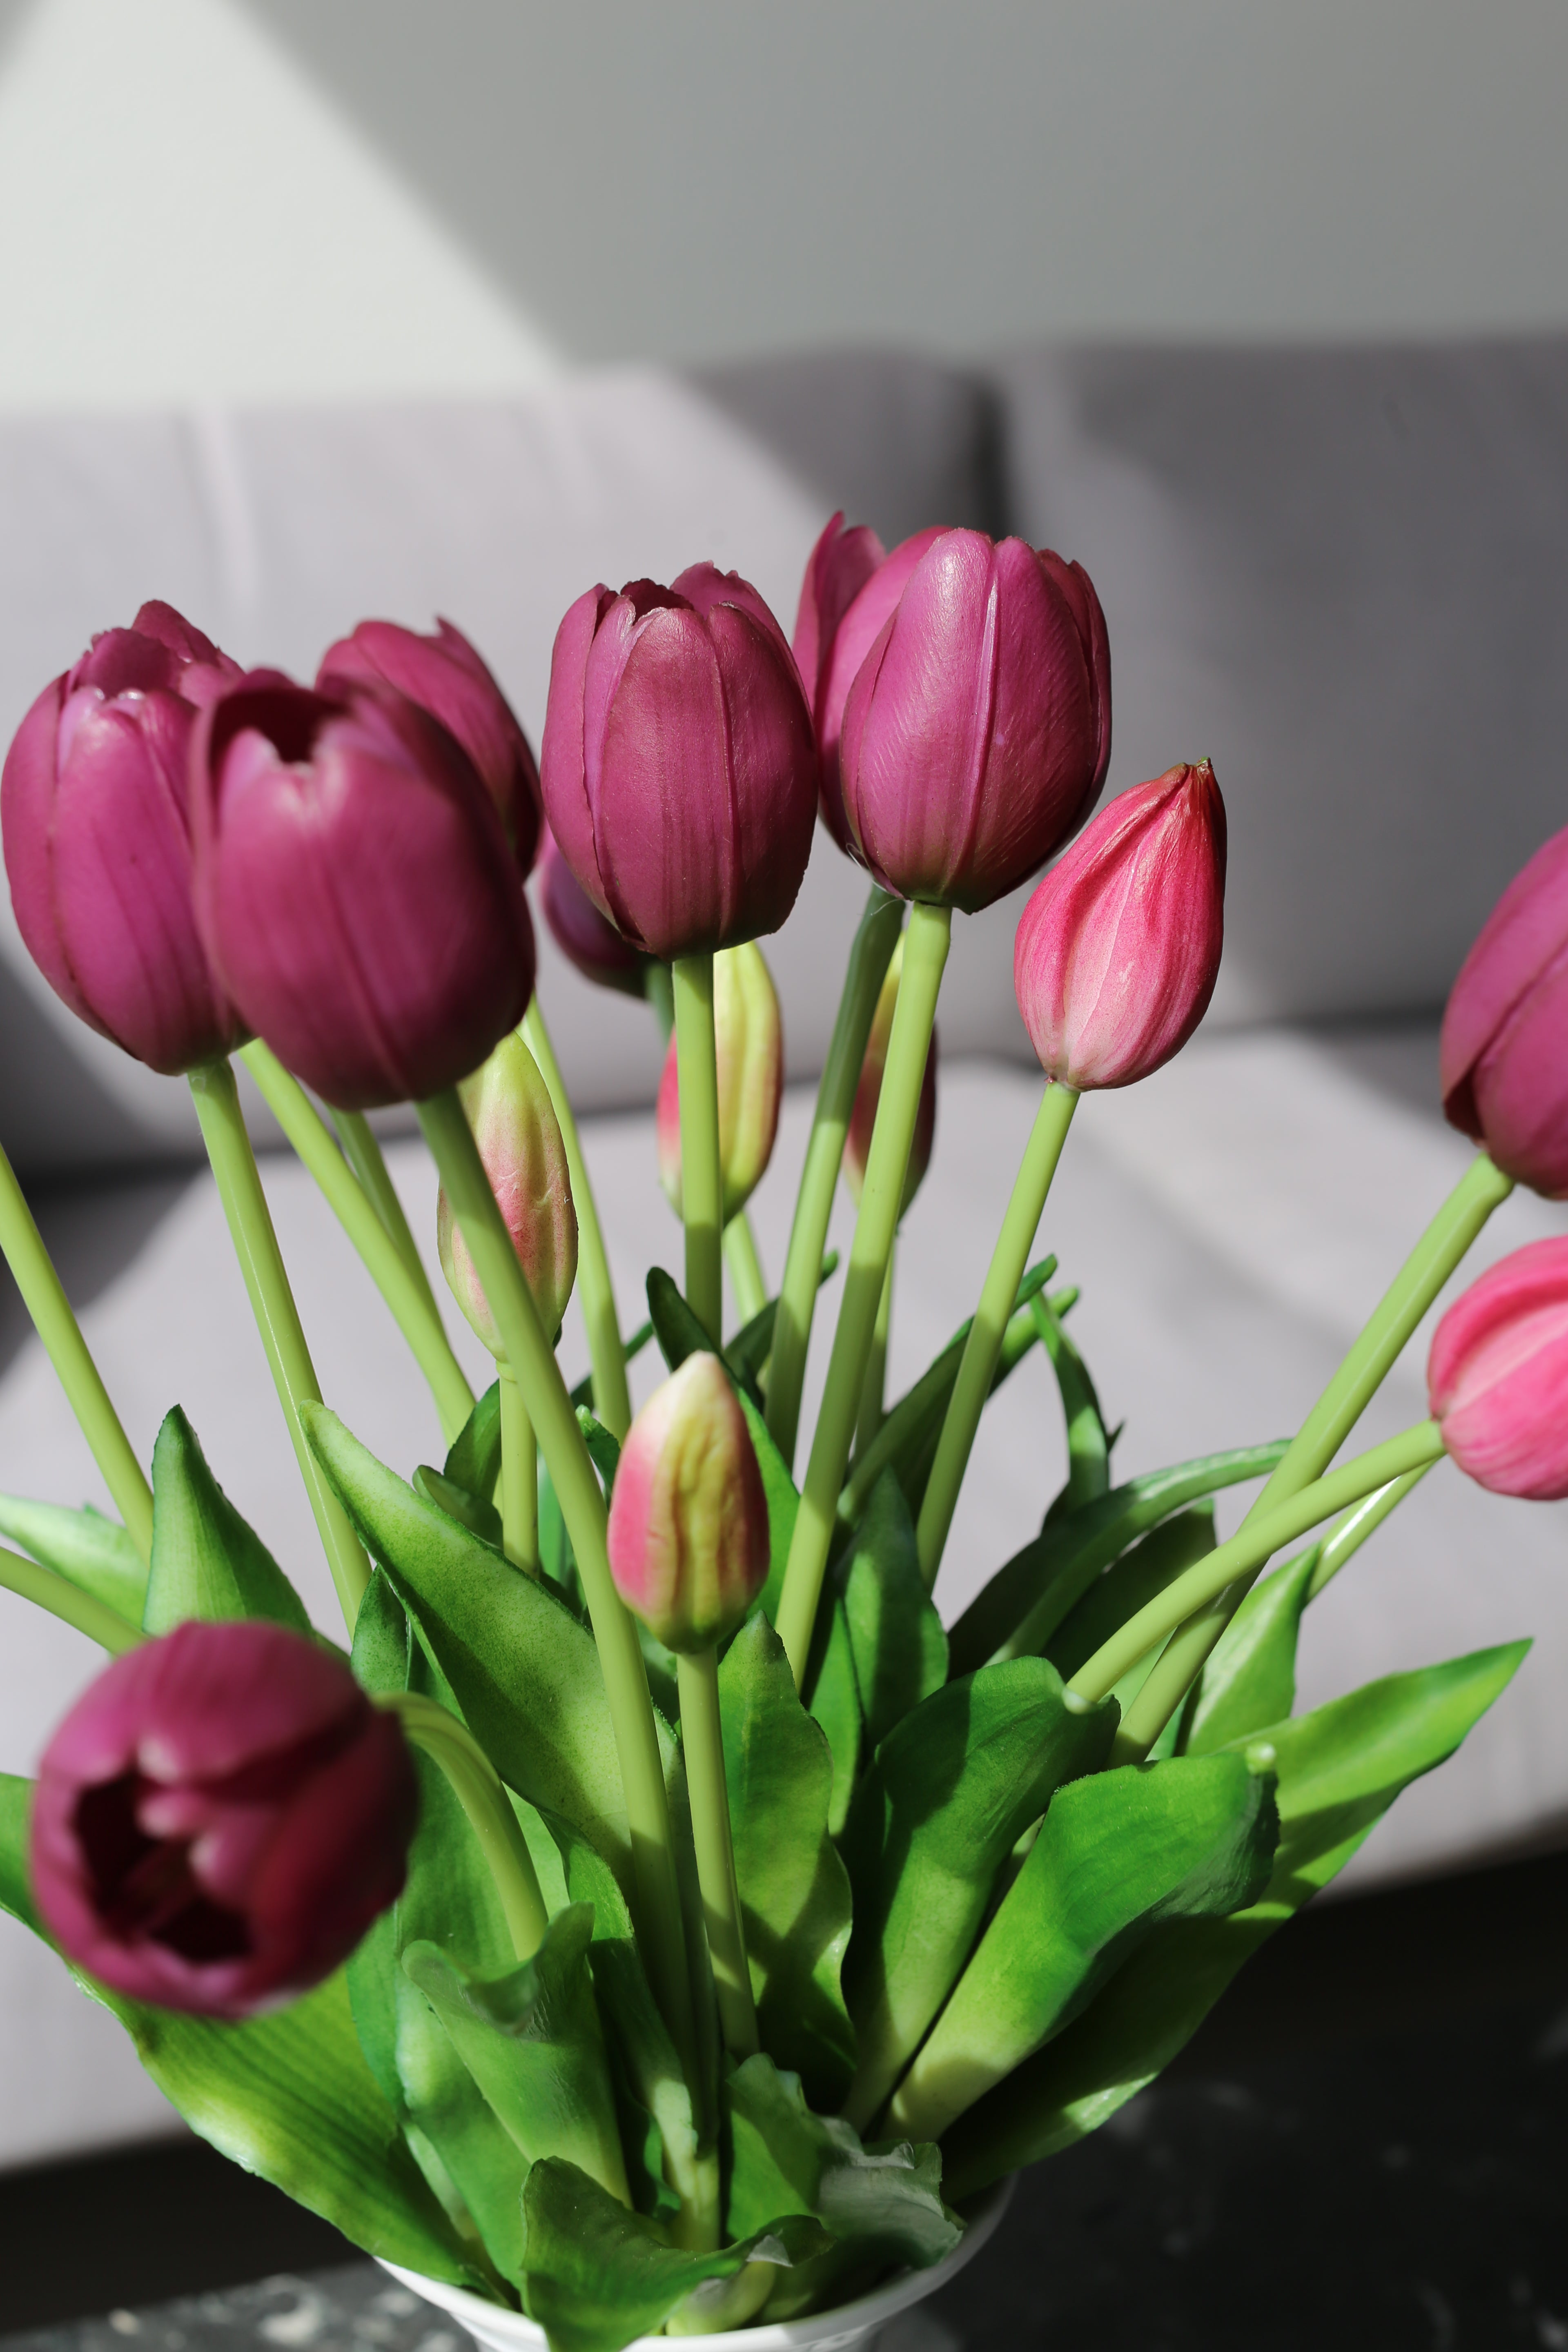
[190, 670, 534, 1110]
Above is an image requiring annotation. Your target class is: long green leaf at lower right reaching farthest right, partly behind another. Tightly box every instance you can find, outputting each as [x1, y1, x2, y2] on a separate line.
[943, 1642, 1530, 2197]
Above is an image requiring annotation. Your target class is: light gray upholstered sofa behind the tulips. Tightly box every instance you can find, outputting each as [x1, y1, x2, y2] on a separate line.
[0, 341, 1568, 2164]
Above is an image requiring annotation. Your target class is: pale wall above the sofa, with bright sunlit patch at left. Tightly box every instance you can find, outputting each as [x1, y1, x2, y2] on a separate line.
[0, 0, 1568, 409]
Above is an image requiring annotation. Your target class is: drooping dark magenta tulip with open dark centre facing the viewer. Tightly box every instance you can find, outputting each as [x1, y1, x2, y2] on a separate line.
[31, 1621, 419, 2018]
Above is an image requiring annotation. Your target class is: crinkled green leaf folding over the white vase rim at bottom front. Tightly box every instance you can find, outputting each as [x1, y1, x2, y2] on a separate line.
[522, 2157, 828, 2352]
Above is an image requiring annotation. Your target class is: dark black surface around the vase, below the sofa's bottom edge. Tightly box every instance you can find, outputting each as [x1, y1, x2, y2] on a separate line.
[0, 1856, 1568, 2352]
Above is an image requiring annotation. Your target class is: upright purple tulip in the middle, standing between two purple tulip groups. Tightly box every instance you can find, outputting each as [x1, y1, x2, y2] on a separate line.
[543, 564, 816, 962]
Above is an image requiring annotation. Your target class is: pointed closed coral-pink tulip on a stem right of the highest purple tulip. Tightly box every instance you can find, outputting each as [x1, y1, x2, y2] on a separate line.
[1013, 760, 1225, 1094]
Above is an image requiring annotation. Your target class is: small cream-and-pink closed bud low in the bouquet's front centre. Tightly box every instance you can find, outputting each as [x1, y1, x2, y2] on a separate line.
[609, 1355, 769, 1651]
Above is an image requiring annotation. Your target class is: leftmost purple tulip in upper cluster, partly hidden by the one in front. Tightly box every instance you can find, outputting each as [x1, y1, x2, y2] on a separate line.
[0, 604, 242, 1073]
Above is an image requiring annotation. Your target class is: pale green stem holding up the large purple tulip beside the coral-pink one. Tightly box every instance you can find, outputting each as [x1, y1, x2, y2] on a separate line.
[778, 903, 952, 1689]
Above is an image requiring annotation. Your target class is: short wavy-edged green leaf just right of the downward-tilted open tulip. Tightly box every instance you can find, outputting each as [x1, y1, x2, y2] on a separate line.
[402, 1903, 628, 2197]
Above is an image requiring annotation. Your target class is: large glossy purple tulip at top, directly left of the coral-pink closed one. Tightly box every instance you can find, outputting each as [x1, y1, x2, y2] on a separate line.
[818, 532, 1109, 913]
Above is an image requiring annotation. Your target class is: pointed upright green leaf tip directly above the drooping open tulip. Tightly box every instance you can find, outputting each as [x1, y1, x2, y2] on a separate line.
[141, 1404, 310, 1635]
